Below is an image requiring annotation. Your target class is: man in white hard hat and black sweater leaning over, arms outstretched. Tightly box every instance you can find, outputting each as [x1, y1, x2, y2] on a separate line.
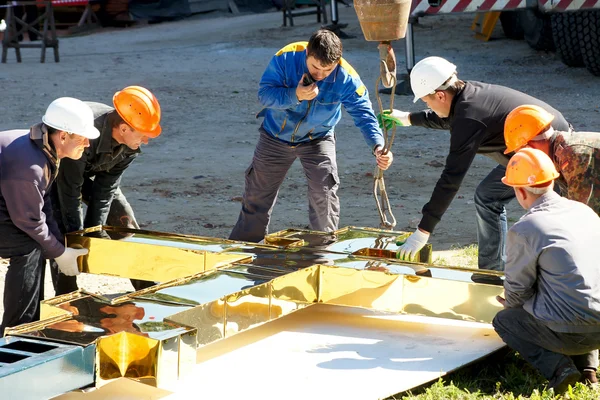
[378, 57, 569, 271]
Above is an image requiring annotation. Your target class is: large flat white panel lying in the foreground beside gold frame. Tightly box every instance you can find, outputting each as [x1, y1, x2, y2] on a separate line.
[165, 305, 504, 400]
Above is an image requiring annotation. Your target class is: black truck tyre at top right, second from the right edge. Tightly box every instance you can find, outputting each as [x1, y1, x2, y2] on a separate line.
[550, 12, 583, 67]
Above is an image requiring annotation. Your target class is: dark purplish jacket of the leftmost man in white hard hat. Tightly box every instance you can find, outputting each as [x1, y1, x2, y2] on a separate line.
[0, 124, 65, 258]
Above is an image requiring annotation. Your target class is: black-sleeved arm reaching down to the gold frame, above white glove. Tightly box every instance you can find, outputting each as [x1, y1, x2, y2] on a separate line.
[419, 120, 485, 233]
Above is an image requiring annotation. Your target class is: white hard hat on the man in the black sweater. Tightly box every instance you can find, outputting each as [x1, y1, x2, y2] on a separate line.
[410, 57, 456, 103]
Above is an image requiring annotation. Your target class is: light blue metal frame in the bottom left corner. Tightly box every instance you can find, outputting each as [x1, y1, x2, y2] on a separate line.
[0, 336, 95, 400]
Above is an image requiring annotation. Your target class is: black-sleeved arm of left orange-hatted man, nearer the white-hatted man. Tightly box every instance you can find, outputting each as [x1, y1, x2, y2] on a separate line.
[55, 153, 87, 233]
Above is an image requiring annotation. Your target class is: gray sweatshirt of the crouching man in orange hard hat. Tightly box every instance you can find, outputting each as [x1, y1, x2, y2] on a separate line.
[504, 191, 600, 333]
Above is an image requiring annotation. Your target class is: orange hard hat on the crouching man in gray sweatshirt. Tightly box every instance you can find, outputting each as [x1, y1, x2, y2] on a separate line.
[502, 147, 559, 187]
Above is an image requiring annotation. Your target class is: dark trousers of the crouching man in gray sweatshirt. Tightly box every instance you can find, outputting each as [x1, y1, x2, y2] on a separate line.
[492, 308, 600, 379]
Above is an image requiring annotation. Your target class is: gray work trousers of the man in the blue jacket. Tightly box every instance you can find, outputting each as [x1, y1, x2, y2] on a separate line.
[229, 127, 340, 242]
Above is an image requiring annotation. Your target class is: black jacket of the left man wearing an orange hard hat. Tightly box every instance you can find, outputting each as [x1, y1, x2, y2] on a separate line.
[57, 102, 140, 232]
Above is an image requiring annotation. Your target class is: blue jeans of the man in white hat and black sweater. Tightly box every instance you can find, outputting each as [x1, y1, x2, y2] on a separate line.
[475, 165, 515, 271]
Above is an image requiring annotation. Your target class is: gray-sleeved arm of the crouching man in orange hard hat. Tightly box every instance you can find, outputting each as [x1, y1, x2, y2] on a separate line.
[504, 229, 539, 308]
